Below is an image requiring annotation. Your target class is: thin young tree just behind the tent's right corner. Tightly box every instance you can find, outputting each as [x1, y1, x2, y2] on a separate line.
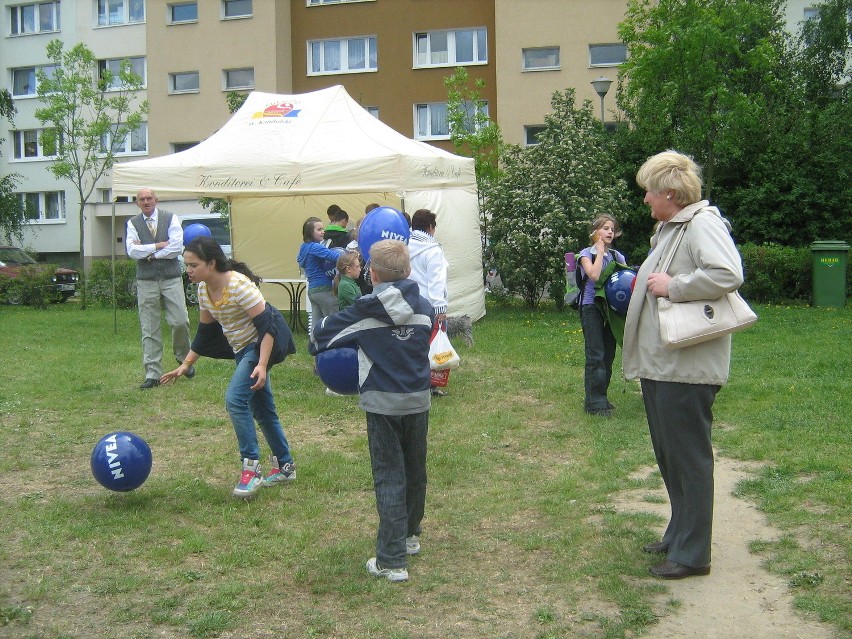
[444, 67, 503, 255]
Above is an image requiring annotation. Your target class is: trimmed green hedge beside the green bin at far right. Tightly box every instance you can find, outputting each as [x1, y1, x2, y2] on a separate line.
[739, 244, 852, 304]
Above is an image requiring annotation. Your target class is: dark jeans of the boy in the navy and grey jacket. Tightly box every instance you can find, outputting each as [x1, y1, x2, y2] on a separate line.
[367, 410, 429, 568]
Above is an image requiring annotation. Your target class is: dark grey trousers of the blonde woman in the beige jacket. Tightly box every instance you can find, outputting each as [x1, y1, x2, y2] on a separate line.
[641, 379, 720, 568]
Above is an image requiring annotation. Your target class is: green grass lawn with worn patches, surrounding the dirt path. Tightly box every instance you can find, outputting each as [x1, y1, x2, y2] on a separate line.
[0, 303, 852, 639]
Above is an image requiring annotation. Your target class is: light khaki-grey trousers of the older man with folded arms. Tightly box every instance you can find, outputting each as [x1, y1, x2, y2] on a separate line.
[136, 277, 190, 379]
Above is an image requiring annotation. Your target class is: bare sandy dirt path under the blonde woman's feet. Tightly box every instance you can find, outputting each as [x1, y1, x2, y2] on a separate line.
[616, 456, 835, 639]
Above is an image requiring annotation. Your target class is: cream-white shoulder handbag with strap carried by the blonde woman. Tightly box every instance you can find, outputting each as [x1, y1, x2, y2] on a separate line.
[657, 224, 757, 350]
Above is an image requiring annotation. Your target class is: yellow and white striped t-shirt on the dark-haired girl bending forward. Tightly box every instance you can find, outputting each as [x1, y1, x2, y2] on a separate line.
[198, 271, 264, 353]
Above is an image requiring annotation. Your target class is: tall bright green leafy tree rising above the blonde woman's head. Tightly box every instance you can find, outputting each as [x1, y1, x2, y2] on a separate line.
[617, 0, 787, 197]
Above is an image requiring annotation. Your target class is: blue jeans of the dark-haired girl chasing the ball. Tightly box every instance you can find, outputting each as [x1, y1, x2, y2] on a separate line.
[225, 344, 293, 464]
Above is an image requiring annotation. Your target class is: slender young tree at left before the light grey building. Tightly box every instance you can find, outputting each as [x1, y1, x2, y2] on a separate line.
[36, 40, 148, 264]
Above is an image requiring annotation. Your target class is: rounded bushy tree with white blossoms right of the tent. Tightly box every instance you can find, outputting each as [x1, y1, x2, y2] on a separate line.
[488, 89, 630, 307]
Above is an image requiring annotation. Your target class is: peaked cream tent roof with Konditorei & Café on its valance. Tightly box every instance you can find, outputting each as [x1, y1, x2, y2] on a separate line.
[112, 85, 476, 198]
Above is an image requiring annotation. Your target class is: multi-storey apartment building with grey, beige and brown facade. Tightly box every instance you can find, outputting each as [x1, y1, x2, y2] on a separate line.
[0, 0, 824, 263]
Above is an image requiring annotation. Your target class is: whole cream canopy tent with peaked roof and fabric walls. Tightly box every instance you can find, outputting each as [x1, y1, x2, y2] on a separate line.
[113, 86, 485, 320]
